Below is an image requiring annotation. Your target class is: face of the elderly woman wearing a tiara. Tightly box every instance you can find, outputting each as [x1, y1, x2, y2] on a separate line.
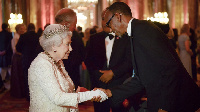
[54, 36, 72, 61]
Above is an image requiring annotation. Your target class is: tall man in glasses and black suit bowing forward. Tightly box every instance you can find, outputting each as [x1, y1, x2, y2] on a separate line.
[98, 2, 200, 112]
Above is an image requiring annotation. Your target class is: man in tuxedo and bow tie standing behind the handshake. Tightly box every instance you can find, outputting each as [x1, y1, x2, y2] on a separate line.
[85, 10, 132, 112]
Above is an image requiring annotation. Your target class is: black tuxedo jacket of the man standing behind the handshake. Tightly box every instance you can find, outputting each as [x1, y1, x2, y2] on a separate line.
[85, 32, 132, 88]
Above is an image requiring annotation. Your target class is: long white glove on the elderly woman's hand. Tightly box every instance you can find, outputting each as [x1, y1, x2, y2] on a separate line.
[78, 89, 108, 103]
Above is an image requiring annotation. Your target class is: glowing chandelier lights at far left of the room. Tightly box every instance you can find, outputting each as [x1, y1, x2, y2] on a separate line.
[8, 13, 23, 32]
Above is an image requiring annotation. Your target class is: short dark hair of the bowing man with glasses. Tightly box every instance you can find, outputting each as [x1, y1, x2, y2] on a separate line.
[108, 2, 132, 17]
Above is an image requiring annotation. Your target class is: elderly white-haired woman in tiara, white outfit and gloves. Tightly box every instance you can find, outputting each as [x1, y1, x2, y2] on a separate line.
[28, 24, 106, 112]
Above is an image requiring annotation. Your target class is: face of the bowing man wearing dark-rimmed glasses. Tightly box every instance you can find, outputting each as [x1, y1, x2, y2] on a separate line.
[105, 11, 126, 37]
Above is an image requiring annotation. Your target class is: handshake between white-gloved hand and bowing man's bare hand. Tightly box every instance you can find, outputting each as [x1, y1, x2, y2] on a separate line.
[78, 88, 112, 103]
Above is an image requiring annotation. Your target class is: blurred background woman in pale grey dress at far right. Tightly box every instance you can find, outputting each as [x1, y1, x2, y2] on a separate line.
[178, 24, 193, 77]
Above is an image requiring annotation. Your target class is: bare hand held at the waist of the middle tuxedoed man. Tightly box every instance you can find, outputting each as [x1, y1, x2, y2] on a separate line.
[99, 70, 114, 83]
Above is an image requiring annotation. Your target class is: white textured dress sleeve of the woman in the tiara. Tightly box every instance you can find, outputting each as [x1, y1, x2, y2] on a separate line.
[30, 61, 78, 107]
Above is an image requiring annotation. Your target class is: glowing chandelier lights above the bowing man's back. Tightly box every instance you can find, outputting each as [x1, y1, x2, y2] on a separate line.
[147, 12, 169, 24]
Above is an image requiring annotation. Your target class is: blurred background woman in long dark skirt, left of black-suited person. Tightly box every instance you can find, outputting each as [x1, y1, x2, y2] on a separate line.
[10, 24, 26, 98]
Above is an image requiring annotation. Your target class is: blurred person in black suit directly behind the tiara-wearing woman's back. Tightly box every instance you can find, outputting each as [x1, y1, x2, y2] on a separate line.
[16, 23, 39, 101]
